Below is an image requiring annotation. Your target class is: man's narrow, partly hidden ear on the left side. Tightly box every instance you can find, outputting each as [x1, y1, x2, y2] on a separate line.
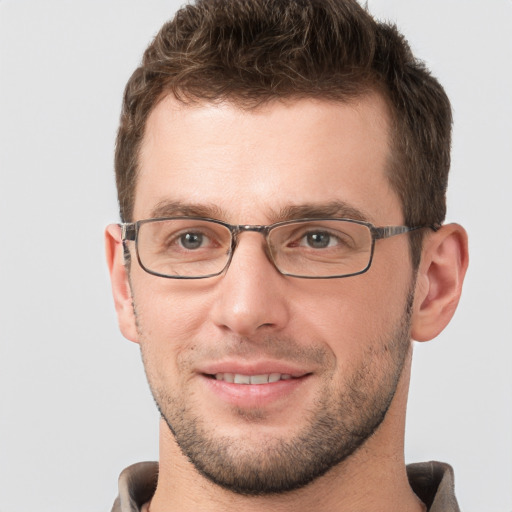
[105, 224, 138, 343]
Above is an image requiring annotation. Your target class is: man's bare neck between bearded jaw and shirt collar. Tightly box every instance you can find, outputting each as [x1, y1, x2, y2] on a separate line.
[151, 354, 426, 512]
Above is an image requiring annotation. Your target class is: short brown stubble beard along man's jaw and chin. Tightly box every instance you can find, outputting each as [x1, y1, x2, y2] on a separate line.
[139, 293, 413, 496]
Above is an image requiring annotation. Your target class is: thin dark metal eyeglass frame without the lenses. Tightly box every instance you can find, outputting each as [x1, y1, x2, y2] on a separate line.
[118, 216, 441, 279]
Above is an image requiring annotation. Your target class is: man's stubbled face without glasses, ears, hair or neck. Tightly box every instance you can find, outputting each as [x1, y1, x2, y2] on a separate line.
[124, 96, 413, 494]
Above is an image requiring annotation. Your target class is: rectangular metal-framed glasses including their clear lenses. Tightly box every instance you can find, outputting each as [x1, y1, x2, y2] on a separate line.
[120, 217, 437, 279]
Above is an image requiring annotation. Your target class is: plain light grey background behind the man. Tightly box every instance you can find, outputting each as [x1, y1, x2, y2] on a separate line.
[0, 0, 512, 512]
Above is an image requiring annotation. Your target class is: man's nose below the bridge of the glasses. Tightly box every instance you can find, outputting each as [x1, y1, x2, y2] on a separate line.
[211, 232, 290, 337]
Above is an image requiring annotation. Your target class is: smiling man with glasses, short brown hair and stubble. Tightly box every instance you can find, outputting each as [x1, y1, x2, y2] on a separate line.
[106, 0, 468, 512]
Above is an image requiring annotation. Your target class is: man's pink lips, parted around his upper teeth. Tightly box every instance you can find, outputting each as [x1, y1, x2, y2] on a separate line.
[198, 361, 313, 409]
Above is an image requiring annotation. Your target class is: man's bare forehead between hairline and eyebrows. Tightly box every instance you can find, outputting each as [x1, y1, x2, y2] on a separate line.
[134, 95, 401, 224]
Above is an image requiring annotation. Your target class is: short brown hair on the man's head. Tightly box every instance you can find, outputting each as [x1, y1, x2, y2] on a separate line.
[115, 0, 452, 266]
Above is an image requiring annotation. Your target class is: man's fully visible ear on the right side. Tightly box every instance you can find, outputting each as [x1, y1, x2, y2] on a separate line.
[411, 224, 469, 341]
